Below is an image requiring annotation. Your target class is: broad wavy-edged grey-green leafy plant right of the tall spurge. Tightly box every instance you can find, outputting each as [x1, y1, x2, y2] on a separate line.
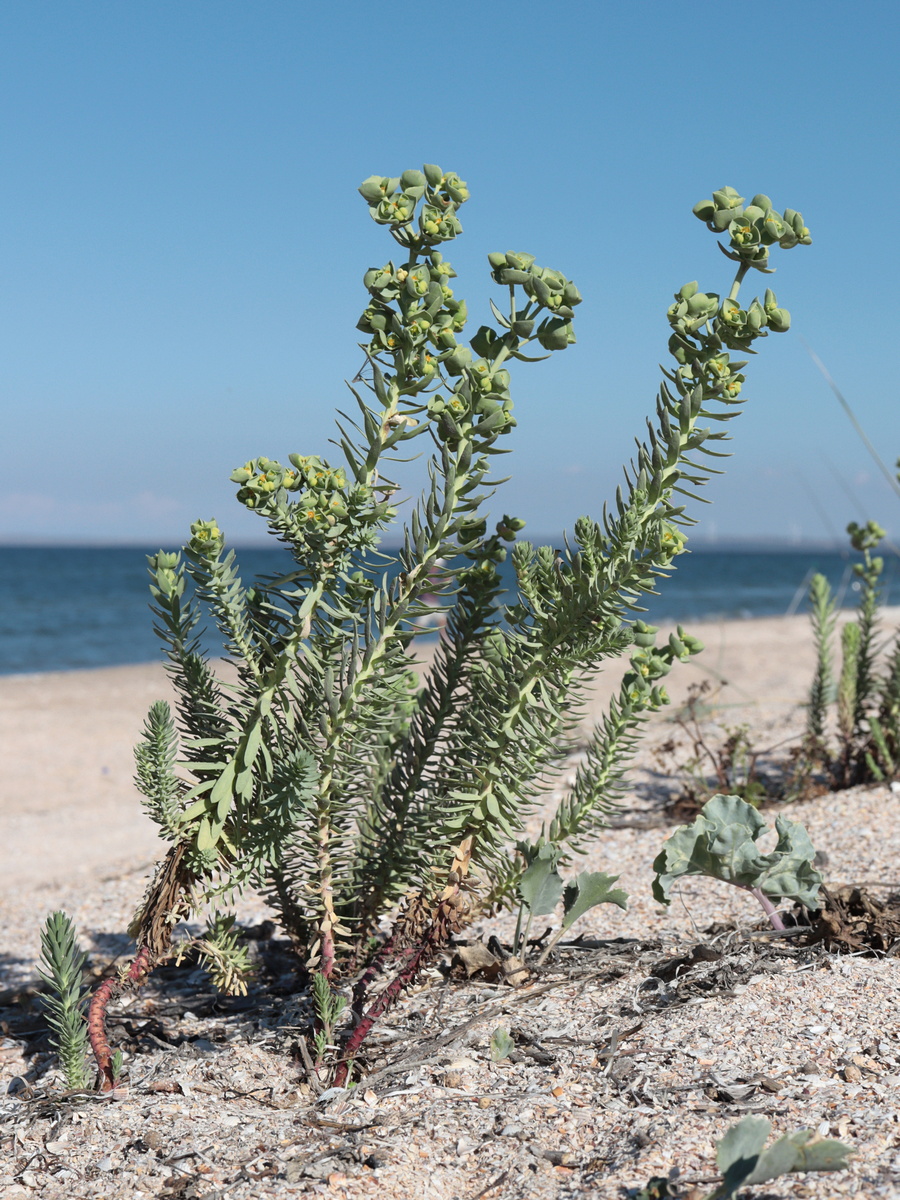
[653, 796, 822, 930]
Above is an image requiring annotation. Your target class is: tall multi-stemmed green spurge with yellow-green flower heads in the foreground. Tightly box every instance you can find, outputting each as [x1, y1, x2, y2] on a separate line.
[91, 166, 810, 1087]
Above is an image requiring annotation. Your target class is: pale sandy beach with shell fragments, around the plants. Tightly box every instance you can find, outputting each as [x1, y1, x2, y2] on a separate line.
[0, 610, 900, 1200]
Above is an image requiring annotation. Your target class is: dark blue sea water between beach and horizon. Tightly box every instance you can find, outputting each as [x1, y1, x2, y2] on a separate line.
[0, 546, 900, 674]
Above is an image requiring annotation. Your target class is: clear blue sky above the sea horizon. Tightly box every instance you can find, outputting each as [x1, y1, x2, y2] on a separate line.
[0, 0, 900, 546]
